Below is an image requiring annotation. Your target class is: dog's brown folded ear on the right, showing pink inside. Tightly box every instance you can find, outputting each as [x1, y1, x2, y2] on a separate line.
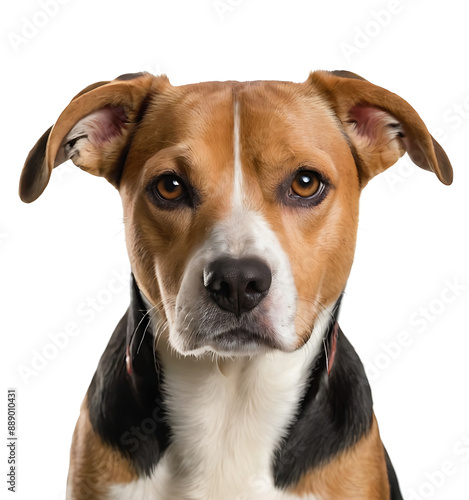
[307, 71, 453, 186]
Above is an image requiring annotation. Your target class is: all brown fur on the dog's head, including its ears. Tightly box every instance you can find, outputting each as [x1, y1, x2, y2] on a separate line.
[19, 72, 449, 345]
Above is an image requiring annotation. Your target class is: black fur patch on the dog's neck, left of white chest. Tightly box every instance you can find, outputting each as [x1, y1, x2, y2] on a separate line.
[88, 277, 169, 475]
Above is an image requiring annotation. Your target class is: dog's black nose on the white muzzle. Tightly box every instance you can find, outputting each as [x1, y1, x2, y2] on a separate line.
[204, 257, 272, 316]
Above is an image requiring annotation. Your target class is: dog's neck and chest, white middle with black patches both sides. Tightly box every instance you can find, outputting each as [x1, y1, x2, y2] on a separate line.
[88, 280, 373, 500]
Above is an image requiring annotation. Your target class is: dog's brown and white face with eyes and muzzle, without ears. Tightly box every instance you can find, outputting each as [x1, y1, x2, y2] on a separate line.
[120, 83, 360, 355]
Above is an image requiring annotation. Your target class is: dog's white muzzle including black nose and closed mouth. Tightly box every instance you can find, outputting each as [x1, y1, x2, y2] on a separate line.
[169, 212, 298, 356]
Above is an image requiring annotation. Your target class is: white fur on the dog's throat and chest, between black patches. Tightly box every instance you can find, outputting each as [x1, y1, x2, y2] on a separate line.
[109, 321, 325, 500]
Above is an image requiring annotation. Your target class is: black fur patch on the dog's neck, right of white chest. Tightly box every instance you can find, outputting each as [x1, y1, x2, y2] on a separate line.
[273, 324, 373, 488]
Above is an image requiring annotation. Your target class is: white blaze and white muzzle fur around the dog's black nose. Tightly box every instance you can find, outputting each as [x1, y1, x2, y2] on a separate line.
[171, 97, 299, 356]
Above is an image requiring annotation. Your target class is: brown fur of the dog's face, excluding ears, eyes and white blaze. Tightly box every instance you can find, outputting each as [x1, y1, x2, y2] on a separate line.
[121, 83, 360, 345]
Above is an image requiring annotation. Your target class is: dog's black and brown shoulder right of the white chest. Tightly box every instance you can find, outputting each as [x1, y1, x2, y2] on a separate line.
[274, 328, 402, 500]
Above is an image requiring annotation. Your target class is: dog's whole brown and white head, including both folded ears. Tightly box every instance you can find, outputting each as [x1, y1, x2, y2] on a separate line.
[20, 71, 452, 356]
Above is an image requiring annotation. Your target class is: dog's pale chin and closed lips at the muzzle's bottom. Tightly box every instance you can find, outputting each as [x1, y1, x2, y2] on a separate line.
[174, 328, 286, 358]
